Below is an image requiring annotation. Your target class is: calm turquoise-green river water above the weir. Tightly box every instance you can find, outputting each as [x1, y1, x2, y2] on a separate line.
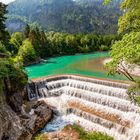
[26, 52, 124, 80]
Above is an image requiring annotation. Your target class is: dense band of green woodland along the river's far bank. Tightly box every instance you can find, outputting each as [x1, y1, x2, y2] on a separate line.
[7, 25, 121, 65]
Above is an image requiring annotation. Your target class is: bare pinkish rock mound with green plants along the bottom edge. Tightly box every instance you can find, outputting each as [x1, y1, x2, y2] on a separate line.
[33, 124, 114, 140]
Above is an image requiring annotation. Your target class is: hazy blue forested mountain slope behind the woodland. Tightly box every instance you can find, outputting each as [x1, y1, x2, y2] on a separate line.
[6, 0, 121, 34]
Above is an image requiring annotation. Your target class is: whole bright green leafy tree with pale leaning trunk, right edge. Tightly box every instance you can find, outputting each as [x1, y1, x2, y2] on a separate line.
[105, 0, 140, 102]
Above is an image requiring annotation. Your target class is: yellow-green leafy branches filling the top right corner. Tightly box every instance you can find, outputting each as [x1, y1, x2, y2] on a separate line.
[119, 0, 140, 33]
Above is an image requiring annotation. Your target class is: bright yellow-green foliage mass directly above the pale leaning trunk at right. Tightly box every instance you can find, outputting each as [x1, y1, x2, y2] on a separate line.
[111, 32, 140, 64]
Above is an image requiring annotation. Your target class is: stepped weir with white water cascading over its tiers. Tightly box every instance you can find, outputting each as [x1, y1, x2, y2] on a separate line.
[27, 75, 140, 140]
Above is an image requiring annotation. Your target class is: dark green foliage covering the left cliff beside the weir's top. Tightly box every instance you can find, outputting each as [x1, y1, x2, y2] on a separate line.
[0, 58, 28, 94]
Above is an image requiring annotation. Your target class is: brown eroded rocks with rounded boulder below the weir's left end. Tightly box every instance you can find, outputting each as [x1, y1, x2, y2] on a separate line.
[0, 101, 52, 140]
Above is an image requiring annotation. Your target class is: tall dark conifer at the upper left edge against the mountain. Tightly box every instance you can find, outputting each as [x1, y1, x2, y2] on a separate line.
[0, 2, 10, 46]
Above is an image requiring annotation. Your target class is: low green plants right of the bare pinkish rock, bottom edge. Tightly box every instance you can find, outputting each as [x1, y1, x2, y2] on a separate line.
[72, 125, 113, 140]
